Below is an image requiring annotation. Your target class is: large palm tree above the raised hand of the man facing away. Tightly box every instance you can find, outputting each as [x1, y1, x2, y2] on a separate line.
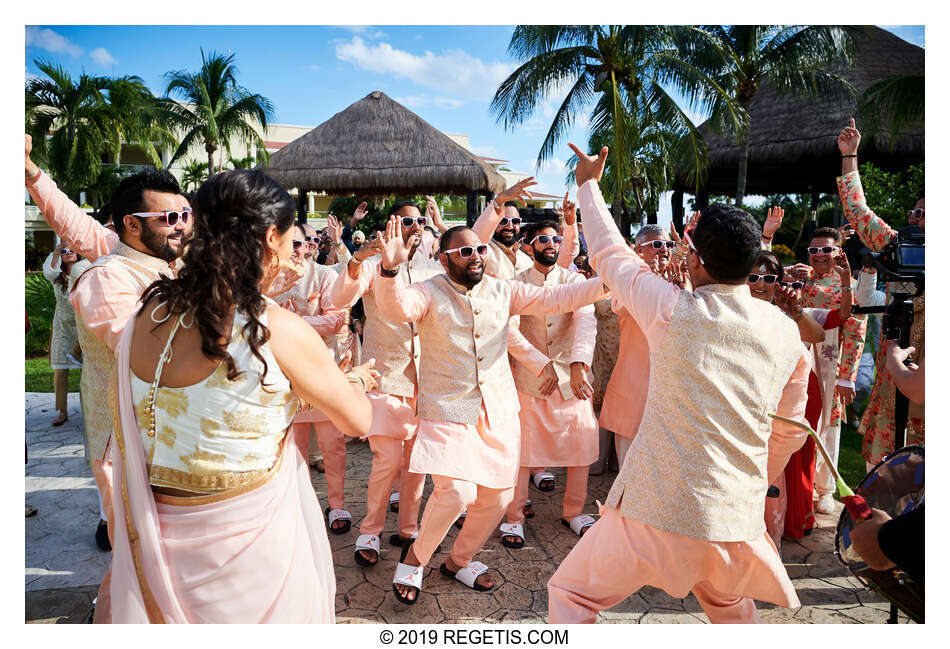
[491, 25, 743, 220]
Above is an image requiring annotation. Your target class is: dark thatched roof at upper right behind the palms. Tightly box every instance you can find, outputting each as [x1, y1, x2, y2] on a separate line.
[675, 26, 924, 195]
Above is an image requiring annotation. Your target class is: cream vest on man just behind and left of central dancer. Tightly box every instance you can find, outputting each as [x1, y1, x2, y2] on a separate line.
[363, 251, 443, 397]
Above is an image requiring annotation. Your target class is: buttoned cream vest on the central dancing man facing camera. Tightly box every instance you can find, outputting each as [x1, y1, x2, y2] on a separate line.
[416, 274, 519, 426]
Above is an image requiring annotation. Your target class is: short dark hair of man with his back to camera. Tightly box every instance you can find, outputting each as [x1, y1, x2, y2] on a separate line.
[690, 203, 762, 282]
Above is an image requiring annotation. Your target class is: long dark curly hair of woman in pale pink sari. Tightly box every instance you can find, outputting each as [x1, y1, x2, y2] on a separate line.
[142, 169, 294, 385]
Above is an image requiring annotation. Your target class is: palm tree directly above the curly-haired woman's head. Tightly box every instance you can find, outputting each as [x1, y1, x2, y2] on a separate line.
[165, 50, 274, 170]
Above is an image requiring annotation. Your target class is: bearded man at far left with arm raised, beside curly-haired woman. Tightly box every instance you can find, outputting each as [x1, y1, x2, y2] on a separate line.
[25, 135, 193, 550]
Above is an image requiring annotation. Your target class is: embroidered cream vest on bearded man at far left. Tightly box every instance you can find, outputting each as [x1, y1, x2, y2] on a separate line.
[74, 242, 172, 464]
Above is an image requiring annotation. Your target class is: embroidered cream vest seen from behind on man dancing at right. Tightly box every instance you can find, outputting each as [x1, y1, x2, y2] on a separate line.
[607, 284, 804, 541]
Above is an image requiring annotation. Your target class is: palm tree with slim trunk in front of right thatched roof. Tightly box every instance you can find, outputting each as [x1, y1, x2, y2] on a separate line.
[687, 25, 854, 206]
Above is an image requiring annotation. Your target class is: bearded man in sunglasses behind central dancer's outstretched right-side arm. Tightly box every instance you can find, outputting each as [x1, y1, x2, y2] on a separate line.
[501, 221, 599, 548]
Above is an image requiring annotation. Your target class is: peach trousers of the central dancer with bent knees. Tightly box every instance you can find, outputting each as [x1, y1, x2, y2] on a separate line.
[410, 474, 515, 566]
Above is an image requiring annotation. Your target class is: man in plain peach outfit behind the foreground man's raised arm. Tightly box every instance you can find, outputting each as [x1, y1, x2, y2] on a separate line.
[604, 225, 678, 466]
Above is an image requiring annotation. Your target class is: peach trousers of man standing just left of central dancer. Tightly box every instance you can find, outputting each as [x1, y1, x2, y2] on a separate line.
[360, 435, 426, 539]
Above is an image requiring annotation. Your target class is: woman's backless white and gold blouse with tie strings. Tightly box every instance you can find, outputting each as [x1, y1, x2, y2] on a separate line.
[129, 304, 297, 493]
